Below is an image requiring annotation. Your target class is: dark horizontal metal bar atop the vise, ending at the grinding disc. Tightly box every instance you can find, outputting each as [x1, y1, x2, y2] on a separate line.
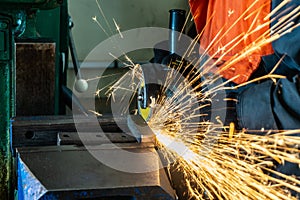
[11, 115, 155, 149]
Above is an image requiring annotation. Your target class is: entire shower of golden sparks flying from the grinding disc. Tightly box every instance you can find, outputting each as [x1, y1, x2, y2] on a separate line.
[95, 0, 300, 199]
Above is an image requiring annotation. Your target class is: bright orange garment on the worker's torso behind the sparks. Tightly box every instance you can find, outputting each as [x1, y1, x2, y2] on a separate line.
[189, 0, 273, 84]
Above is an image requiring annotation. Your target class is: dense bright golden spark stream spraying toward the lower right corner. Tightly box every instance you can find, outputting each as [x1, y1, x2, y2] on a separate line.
[157, 130, 300, 199]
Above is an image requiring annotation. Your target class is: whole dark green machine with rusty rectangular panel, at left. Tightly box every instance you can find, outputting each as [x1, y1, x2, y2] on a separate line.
[0, 0, 69, 199]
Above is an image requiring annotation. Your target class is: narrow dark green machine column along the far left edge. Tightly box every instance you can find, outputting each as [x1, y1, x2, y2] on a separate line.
[0, 13, 15, 200]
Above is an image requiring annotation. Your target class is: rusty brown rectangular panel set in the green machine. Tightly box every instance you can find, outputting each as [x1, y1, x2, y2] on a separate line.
[16, 42, 55, 116]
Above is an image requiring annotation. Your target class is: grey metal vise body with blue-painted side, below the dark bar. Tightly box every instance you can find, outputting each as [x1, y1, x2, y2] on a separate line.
[17, 144, 175, 200]
